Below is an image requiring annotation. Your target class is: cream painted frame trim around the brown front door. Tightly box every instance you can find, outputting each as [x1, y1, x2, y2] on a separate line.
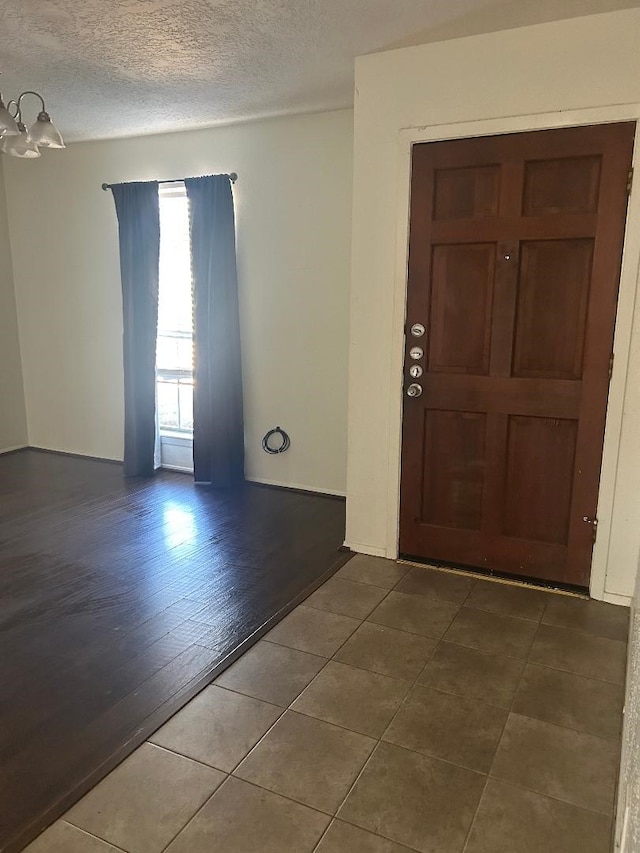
[386, 104, 640, 604]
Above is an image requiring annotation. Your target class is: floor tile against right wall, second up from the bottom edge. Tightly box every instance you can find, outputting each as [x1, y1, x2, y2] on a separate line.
[491, 714, 619, 815]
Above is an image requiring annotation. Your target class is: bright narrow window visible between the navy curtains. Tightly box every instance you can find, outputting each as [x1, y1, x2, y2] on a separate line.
[156, 182, 193, 470]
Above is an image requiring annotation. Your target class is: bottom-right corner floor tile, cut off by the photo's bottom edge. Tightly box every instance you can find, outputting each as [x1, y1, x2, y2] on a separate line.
[465, 779, 611, 853]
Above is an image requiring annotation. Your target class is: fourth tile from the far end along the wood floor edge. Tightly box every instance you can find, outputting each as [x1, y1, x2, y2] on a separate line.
[215, 640, 327, 708]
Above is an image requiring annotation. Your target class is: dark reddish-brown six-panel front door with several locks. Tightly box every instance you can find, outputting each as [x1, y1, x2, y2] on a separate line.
[400, 123, 635, 586]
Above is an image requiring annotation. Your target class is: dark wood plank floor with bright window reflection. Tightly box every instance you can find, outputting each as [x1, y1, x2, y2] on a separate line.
[0, 450, 344, 851]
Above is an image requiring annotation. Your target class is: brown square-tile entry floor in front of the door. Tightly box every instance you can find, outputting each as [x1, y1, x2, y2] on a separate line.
[27, 556, 628, 853]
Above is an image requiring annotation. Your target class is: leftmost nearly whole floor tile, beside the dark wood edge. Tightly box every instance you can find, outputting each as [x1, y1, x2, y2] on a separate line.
[65, 743, 224, 853]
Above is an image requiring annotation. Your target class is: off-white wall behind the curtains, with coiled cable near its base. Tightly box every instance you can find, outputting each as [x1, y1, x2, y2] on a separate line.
[6, 111, 353, 492]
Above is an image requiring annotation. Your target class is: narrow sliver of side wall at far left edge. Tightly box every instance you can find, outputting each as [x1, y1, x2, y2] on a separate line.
[0, 163, 27, 453]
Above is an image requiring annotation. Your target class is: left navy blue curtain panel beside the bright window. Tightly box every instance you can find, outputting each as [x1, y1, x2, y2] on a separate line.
[111, 181, 160, 477]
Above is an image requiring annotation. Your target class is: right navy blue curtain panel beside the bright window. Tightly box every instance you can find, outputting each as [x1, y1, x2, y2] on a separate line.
[185, 175, 244, 488]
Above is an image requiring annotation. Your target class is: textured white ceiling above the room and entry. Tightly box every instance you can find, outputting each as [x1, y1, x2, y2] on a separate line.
[0, 0, 640, 141]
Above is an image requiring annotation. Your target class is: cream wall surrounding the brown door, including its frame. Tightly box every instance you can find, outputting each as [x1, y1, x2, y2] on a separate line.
[347, 9, 640, 601]
